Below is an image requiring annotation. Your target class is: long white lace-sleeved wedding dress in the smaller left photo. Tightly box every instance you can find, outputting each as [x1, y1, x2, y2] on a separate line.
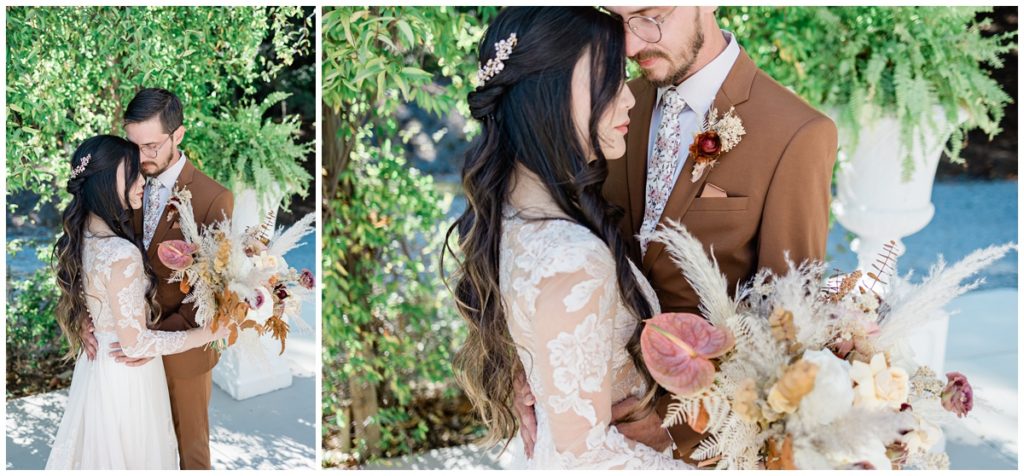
[46, 233, 208, 470]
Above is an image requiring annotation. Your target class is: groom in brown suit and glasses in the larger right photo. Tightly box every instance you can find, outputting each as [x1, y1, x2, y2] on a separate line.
[516, 6, 838, 463]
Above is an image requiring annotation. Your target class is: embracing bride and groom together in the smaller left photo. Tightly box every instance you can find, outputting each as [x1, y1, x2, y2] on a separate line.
[46, 88, 233, 469]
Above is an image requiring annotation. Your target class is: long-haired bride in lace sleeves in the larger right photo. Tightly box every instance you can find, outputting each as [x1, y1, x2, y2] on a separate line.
[447, 7, 690, 469]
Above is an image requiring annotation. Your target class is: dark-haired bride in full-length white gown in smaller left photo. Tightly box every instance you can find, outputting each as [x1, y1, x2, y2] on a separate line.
[46, 135, 226, 469]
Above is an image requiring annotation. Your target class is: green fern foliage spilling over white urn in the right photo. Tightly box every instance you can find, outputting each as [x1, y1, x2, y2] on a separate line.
[719, 6, 1017, 177]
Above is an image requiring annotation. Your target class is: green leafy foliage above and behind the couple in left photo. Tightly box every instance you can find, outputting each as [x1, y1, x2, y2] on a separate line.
[6, 7, 311, 214]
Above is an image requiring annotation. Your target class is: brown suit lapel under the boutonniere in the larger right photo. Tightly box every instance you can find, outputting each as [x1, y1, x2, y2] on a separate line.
[643, 49, 757, 272]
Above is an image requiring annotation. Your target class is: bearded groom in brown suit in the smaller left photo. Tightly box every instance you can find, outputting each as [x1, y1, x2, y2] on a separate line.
[83, 88, 234, 470]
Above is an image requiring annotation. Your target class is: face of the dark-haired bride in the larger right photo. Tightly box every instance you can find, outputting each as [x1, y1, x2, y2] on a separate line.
[572, 51, 636, 160]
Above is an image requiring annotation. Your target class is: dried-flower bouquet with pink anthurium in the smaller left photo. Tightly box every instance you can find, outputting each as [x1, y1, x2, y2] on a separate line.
[157, 186, 315, 353]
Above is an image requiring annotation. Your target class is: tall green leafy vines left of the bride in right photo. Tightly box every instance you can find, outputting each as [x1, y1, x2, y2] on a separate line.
[322, 7, 496, 460]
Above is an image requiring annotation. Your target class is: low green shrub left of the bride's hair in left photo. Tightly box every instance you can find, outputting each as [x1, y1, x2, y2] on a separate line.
[5, 267, 71, 398]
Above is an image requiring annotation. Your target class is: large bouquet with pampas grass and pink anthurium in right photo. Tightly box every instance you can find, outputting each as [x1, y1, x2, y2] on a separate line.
[641, 223, 1016, 470]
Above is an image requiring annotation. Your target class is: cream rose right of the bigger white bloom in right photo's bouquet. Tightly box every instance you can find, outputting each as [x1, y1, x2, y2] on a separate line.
[850, 353, 910, 409]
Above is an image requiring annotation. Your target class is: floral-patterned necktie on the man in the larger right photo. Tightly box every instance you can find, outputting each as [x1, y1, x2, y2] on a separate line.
[640, 88, 686, 256]
